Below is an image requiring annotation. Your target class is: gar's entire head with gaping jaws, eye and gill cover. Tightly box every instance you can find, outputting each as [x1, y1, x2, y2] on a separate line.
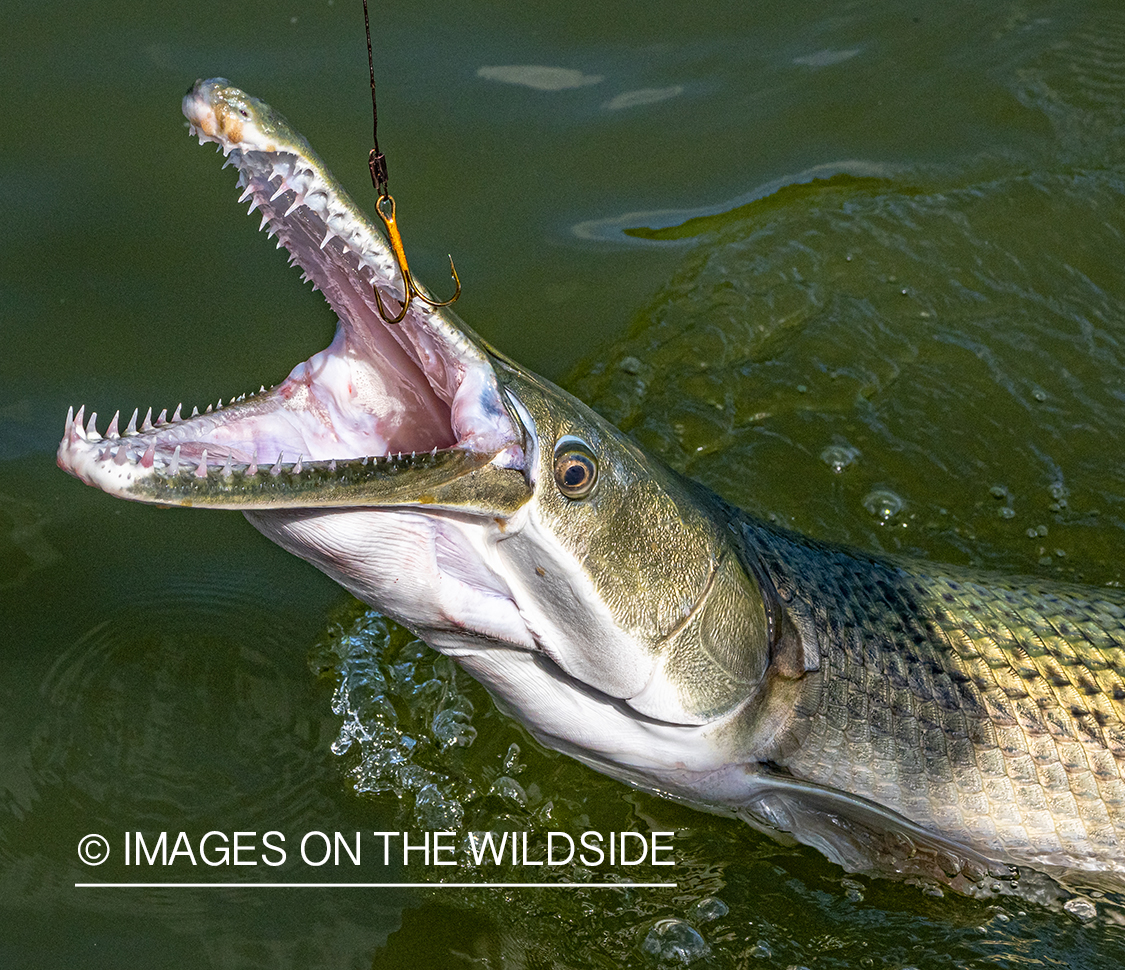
[59, 79, 776, 780]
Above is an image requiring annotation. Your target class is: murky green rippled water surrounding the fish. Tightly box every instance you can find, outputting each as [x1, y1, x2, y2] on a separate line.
[0, 0, 1125, 970]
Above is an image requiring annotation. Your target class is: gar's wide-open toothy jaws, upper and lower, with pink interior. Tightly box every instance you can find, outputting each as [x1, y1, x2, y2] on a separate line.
[59, 79, 523, 508]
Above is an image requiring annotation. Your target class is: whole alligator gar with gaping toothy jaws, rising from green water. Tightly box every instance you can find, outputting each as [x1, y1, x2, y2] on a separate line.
[59, 79, 1125, 891]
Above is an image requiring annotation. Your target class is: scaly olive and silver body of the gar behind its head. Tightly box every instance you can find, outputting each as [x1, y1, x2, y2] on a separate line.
[743, 520, 1125, 873]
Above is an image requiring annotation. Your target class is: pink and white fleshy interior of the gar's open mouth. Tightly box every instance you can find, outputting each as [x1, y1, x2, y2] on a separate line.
[62, 155, 469, 467]
